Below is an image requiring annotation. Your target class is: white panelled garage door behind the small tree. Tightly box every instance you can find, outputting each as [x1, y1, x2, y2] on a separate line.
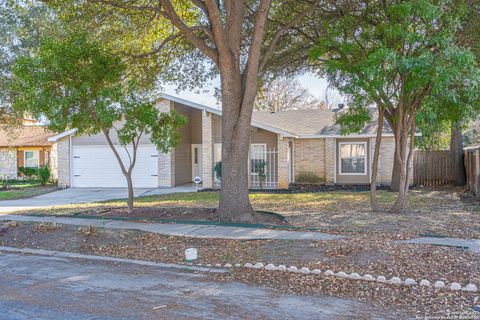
[72, 145, 158, 188]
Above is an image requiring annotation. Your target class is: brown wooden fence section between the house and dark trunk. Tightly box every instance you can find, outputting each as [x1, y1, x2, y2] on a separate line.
[413, 151, 453, 186]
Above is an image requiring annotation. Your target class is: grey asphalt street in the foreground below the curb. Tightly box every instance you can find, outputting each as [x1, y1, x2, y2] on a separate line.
[0, 253, 397, 320]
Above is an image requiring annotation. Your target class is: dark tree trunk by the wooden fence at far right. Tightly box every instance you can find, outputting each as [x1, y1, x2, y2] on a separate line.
[450, 122, 466, 186]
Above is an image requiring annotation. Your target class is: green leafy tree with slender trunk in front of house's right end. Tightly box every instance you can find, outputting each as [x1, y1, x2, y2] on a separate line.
[311, 0, 478, 211]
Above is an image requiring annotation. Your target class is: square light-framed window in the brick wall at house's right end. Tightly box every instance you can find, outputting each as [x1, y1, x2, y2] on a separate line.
[339, 142, 367, 175]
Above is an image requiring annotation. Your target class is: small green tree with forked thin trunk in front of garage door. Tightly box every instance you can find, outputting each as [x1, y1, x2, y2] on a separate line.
[12, 34, 186, 211]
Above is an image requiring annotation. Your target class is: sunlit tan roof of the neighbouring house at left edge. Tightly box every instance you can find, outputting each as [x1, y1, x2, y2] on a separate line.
[0, 125, 55, 147]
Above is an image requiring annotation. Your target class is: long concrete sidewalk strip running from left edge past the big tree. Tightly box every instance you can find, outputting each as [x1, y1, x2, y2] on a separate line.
[0, 215, 343, 240]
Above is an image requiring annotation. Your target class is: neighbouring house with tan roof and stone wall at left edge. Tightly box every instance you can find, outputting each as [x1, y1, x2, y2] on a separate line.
[0, 124, 56, 179]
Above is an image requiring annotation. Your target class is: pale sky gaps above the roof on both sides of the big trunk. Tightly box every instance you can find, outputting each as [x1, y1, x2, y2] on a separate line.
[163, 73, 328, 107]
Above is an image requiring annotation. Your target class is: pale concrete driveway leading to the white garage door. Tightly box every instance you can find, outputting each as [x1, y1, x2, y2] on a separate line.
[0, 185, 195, 213]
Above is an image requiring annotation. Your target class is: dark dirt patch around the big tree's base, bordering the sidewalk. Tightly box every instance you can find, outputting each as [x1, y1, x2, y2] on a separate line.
[78, 207, 288, 225]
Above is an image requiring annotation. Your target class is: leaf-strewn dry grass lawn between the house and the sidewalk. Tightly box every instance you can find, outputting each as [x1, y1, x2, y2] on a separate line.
[12, 188, 480, 239]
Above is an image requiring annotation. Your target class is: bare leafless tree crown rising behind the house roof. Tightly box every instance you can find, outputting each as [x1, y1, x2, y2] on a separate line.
[255, 78, 325, 112]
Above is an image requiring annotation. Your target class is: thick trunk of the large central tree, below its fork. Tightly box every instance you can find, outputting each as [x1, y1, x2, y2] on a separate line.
[218, 70, 255, 222]
